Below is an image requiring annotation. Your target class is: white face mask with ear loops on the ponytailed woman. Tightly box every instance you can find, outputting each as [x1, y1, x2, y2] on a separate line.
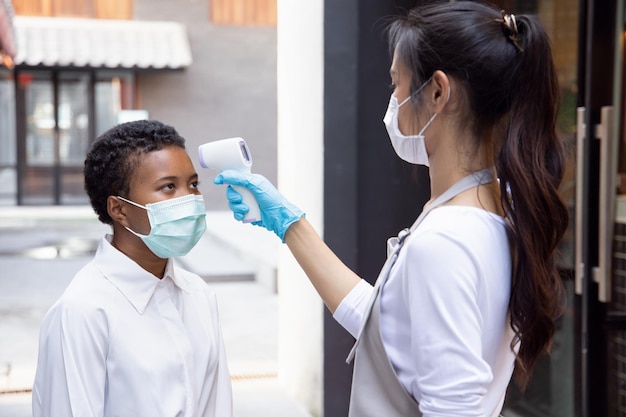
[383, 78, 450, 166]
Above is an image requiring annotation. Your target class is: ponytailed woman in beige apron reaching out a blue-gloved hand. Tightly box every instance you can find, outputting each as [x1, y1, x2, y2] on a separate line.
[215, 1, 568, 417]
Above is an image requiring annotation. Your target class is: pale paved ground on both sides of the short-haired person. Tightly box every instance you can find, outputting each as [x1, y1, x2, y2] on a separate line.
[0, 207, 309, 417]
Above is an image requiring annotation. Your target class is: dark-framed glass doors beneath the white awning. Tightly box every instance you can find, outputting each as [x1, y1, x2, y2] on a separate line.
[17, 71, 93, 205]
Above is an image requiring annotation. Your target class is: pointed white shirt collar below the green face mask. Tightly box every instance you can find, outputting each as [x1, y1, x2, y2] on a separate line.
[93, 234, 190, 314]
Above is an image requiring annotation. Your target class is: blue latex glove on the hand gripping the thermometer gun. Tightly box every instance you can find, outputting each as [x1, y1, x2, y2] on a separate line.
[213, 169, 305, 242]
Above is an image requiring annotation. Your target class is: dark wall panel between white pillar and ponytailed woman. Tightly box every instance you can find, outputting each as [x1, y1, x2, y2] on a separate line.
[324, 0, 429, 417]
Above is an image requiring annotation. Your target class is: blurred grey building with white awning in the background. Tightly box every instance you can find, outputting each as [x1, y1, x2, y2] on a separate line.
[0, 0, 276, 207]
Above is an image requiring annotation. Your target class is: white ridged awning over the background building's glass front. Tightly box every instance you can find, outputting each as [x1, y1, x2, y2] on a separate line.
[13, 16, 192, 69]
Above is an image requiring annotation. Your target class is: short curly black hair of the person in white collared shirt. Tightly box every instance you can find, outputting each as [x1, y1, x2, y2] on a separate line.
[83, 120, 185, 224]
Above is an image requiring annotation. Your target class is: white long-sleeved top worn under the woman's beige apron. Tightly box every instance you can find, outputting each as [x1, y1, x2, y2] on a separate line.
[334, 206, 515, 417]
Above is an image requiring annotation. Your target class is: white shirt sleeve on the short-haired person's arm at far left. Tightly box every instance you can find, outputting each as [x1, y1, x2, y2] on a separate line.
[32, 304, 106, 417]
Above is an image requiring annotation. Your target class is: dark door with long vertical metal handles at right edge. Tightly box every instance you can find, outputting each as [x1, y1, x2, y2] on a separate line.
[576, 0, 626, 417]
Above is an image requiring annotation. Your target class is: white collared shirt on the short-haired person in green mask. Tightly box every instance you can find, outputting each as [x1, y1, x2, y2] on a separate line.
[33, 236, 232, 417]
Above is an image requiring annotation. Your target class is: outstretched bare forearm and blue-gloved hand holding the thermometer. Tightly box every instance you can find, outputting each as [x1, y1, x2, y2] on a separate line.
[214, 170, 361, 312]
